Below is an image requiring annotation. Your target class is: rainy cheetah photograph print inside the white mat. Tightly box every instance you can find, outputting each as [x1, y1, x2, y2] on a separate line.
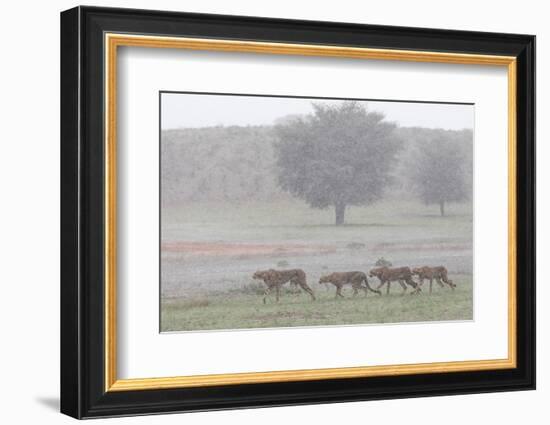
[159, 92, 474, 332]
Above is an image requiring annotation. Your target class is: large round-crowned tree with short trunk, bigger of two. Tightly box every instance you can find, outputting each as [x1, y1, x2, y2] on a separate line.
[274, 102, 400, 225]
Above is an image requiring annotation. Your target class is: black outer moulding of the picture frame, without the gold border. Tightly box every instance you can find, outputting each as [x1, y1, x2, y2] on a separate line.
[61, 7, 535, 418]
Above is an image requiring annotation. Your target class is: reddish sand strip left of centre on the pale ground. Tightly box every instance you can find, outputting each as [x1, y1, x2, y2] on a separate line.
[162, 242, 336, 256]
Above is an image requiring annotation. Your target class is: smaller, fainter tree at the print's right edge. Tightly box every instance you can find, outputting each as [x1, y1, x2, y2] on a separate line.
[410, 130, 472, 216]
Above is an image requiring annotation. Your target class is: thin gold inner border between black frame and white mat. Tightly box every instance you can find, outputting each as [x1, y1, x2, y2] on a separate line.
[104, 33, 517, 391]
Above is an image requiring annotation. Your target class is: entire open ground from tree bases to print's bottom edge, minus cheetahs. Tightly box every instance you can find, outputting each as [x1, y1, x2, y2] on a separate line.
[161, 201, 473, 331]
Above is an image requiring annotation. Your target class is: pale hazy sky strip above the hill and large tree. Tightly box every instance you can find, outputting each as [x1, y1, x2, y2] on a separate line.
[161, 93, 474, 130]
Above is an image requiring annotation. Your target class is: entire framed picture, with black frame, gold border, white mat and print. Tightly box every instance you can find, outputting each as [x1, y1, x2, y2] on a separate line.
[61, 7, 535, 418]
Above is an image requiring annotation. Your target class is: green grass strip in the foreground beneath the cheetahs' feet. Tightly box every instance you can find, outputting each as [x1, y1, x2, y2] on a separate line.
[161, 275, 473, 332]
